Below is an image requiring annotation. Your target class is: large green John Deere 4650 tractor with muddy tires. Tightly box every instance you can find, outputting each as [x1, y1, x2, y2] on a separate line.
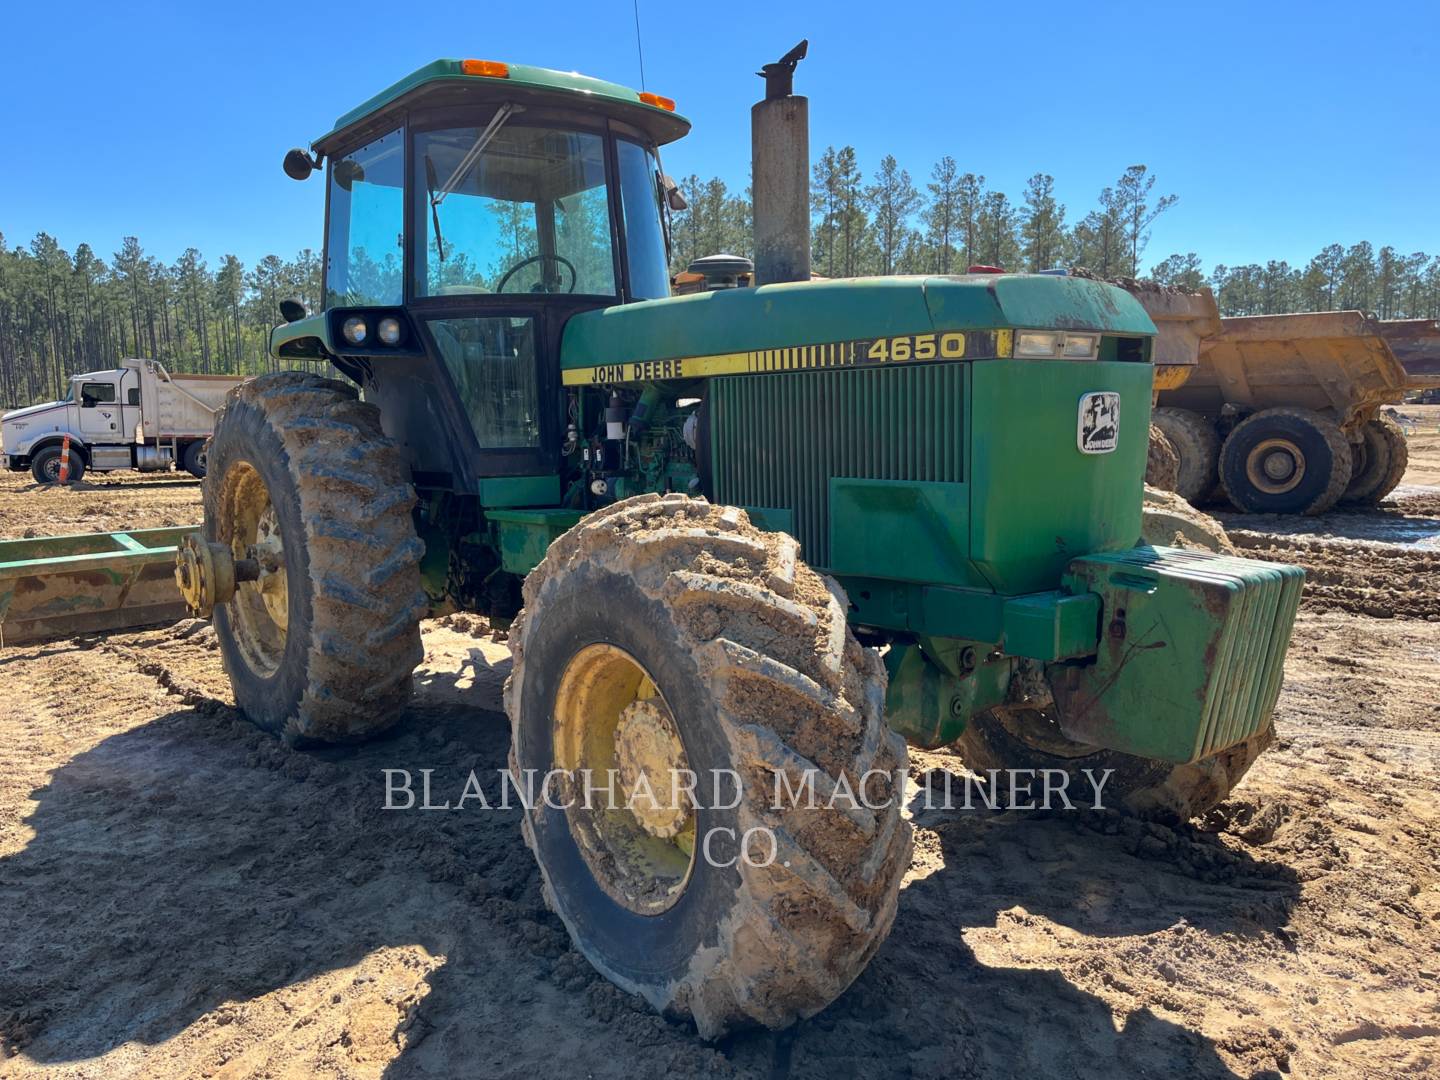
[176, 60, 1300, 1037]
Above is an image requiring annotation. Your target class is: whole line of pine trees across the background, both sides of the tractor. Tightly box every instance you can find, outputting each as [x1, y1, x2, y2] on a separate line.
[0, 147, 1440, 408]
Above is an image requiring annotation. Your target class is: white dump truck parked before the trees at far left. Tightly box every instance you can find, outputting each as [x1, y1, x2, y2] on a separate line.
[0, 360, 243, 484]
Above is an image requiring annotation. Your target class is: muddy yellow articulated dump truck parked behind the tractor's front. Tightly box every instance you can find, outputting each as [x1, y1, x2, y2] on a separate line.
[1116, 279, 1440, 514]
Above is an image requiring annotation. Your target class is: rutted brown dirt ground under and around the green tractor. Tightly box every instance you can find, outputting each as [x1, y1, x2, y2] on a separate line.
[0, 426, 1440, 1080]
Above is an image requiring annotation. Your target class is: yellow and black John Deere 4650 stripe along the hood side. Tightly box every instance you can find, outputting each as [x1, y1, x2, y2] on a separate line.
[562, 330, 1012, 386]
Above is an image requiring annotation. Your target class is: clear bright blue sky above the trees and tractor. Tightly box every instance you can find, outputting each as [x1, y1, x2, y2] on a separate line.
[0, 0, 1440, 275]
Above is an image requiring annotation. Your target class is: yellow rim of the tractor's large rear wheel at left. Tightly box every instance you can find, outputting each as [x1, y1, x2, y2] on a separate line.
[220, 462, 289, 675]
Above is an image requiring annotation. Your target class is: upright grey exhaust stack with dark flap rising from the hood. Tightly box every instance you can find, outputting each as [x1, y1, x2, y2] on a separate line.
[750, 40, 811, 285]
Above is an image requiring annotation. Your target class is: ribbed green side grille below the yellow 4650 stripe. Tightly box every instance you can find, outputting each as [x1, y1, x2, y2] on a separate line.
[708, 363, 966, 567]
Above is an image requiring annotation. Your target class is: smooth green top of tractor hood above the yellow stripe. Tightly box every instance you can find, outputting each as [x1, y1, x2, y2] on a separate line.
[560, 274, 1155, 382]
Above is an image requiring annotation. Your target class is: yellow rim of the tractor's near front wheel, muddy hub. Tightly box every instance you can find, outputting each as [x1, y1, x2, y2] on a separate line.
[552, 644, 696, 914]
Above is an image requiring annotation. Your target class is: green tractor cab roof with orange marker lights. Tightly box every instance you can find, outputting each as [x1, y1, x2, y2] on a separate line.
[311, 59, 690, 153]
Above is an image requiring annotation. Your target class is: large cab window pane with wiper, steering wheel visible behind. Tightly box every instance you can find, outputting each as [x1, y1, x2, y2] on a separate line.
[415, 120, 619, 297]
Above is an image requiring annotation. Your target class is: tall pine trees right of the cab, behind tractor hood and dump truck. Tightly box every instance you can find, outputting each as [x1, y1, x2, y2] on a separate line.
[674, 147, 1440, 318]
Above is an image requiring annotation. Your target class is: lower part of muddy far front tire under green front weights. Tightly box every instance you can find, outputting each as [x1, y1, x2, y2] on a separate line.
[956, 708, 1274, 825]
